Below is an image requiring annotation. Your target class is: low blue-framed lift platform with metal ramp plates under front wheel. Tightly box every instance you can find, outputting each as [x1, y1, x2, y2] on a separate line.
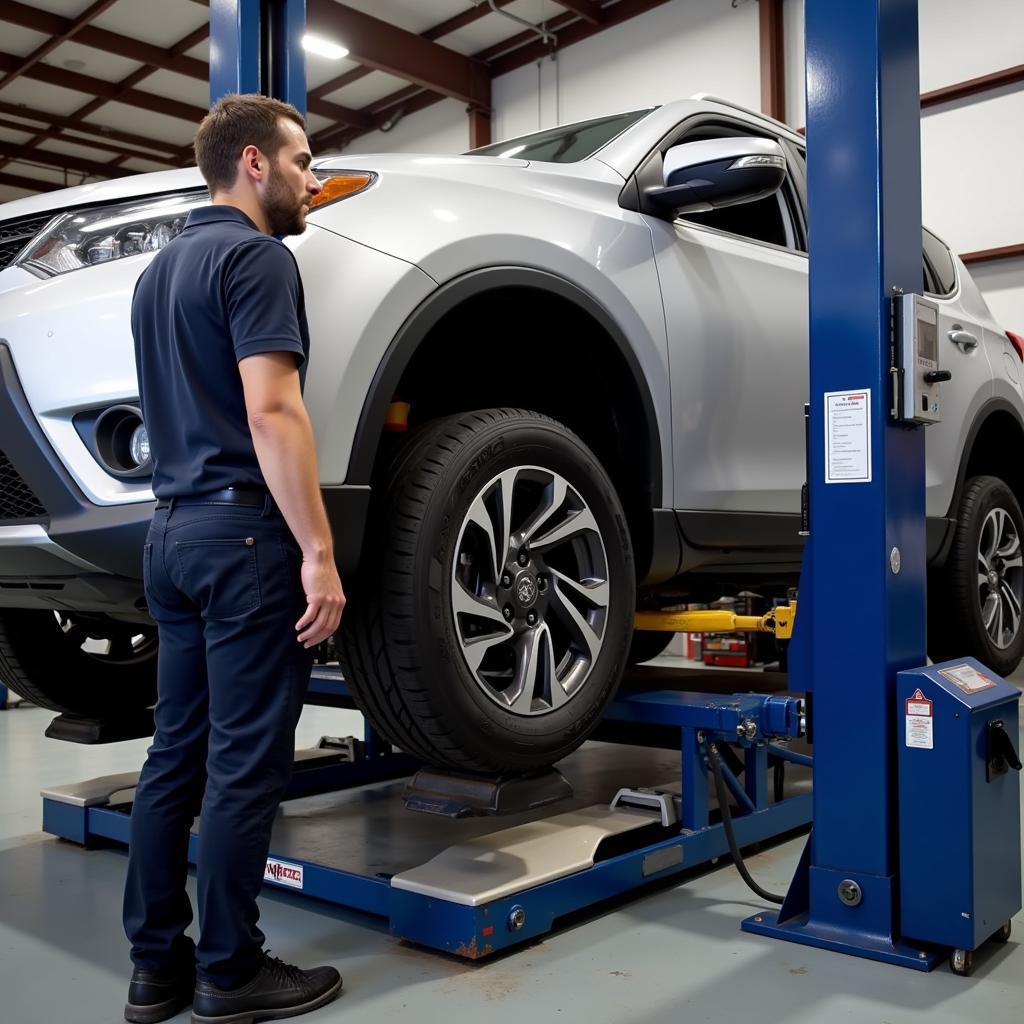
[43, 668, 811, 959]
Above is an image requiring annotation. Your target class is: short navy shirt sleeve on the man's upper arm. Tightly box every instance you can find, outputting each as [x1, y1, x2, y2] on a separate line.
[223, 236, 305, 367]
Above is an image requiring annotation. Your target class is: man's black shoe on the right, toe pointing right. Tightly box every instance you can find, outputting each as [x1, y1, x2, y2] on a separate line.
[193, 953, 341, 1024]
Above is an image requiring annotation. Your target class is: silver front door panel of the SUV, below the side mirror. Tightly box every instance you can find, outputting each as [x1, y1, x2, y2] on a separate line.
[651, 124, 808, 515]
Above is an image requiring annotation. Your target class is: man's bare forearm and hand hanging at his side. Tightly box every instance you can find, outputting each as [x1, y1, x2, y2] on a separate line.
[239, 352, 345, 647]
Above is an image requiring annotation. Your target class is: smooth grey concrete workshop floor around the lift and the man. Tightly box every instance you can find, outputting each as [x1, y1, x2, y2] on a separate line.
[0, 659, 1024, 1024]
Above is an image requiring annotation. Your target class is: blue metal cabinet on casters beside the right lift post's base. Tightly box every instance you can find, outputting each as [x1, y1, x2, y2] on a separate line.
[896, 658, 1021, 949]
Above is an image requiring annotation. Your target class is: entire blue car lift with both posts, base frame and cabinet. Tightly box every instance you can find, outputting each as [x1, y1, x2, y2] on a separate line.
[37, 0, 1021, 973]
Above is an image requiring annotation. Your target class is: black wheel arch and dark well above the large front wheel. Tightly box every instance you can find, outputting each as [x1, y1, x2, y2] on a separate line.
[346, 266, 663, 571]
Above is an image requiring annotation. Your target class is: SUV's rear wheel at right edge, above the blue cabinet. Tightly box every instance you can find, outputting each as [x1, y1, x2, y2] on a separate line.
[929, 476, 1024, 676]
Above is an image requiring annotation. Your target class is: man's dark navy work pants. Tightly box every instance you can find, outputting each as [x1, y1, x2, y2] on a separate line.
[124, 500, 313, 988]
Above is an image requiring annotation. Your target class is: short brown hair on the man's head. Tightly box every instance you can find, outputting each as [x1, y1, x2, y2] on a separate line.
[193, 92, 306, 191]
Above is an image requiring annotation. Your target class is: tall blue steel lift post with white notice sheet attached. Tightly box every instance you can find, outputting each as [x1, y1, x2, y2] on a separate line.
[743, 0, 937, 970]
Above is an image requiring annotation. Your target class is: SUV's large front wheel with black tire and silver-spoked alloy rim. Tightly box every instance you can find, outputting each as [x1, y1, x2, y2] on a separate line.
[339, 409, 636, 772]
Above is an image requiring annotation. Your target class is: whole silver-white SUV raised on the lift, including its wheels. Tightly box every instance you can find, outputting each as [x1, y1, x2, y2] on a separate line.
[0, 97, 1024, 769]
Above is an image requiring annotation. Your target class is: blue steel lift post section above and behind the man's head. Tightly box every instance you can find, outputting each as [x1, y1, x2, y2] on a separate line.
[210, 0, 306, 114]
